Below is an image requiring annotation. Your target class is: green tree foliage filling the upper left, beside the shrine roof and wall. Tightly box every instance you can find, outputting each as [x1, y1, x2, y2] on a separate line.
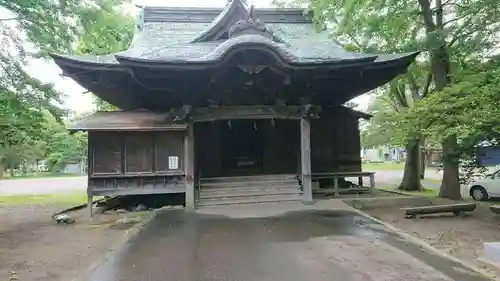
[0, 0, 133, 177]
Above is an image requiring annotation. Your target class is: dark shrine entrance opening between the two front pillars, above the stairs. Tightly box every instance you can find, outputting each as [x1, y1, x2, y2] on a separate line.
[194, 119, 300, 177]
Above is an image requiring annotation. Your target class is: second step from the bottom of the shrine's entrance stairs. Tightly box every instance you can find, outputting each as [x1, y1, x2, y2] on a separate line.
[199, 188, 302, 200]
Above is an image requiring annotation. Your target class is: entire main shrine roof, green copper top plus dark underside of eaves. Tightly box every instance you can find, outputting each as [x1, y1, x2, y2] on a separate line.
[52, 0, 417, 110]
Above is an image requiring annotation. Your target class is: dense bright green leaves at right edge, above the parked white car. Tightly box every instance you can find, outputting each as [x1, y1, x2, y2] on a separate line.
[401, 59, 500, 150]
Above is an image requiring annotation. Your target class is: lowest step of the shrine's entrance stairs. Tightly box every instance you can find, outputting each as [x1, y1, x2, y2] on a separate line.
[197, 192, 302, 206]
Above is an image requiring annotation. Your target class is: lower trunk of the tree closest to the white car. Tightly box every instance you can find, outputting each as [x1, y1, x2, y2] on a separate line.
[439, 135, 462, 200]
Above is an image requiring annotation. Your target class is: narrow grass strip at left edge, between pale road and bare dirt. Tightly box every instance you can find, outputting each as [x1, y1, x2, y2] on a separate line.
[0, 192, 87, 205]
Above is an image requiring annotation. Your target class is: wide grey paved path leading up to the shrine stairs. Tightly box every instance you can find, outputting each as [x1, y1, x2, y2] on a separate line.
[87, 204, 486, 281]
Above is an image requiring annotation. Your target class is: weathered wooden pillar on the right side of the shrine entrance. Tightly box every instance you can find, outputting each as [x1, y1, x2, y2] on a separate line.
[300, 118, 313, 204]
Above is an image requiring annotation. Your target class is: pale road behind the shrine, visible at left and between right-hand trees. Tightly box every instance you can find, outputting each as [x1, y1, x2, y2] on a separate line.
[0, 168, 441, 195]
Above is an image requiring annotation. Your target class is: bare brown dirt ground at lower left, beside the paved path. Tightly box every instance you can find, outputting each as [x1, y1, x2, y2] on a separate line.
[0, 204, 147, 281]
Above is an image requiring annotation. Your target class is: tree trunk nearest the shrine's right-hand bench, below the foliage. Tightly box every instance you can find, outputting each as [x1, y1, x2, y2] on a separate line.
[398, 140, 422, 191]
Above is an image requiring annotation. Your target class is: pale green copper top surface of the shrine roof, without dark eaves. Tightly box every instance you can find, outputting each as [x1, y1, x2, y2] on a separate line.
[50, 0, 390, 66]
